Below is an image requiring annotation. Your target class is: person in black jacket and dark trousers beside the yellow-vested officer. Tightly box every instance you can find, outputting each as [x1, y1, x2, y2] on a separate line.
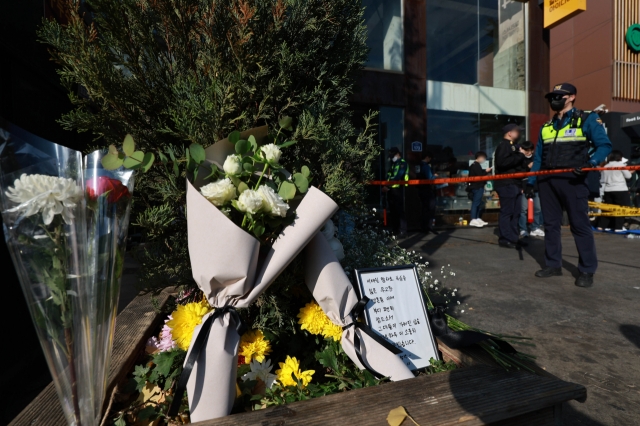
[494, 123, 532, 248]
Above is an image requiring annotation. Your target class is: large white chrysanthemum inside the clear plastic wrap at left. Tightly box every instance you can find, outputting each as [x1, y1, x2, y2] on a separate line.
[6, 174, 83, 225]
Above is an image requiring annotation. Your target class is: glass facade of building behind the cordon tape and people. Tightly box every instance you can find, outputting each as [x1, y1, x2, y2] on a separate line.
[363, 0, 529, 213]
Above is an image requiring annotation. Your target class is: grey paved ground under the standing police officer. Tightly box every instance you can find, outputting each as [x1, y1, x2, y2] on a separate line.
[401, 227, 640, 426]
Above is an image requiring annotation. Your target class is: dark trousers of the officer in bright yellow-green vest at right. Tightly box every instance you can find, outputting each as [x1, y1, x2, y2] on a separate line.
[538, 174, 598, 273]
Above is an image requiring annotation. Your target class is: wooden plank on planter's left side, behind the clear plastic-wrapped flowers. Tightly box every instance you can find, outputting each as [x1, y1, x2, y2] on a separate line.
[9, 290, 170, 426]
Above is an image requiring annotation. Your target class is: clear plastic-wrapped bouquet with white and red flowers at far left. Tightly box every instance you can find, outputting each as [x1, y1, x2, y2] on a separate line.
[0, 126, 133, 426]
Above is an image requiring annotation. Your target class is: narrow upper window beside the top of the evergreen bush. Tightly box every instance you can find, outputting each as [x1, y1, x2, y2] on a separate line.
[362, 0, 404, 71]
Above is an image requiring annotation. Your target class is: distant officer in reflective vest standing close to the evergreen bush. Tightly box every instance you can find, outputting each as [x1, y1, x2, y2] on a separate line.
[382, 146, 409, 238]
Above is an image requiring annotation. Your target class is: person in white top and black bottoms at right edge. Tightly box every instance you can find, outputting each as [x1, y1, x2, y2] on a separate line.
[600, 149, 635, 232]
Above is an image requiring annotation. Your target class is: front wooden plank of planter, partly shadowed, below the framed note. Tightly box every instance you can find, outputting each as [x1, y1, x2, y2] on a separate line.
[194, 365, 586, 426]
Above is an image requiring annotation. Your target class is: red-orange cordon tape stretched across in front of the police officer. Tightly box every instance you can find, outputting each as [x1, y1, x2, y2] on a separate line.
[369, 165, 640, 186]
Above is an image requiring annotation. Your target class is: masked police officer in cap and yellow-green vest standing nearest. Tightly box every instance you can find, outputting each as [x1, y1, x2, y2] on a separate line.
[525, 83, 611, 287]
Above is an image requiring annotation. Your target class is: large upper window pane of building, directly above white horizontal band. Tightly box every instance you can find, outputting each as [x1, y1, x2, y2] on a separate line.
[427, 0, 525, 90]
